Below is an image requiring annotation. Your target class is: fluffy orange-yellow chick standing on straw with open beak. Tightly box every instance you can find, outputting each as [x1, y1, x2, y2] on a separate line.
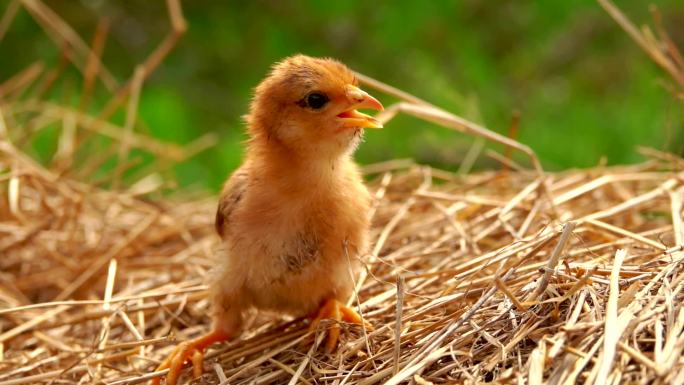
[154, 55, 383, 385]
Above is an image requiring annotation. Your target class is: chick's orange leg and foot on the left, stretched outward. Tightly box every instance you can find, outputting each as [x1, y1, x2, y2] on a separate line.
[152, 330, 230, 385]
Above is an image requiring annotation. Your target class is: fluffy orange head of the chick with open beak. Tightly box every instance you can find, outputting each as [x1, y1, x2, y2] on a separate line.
[247, 55, 383, 156]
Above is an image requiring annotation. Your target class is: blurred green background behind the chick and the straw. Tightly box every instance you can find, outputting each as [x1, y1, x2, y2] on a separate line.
[0, 0, 684, 190]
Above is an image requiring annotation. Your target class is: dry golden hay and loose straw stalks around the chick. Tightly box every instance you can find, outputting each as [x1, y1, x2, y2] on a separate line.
[0, 1, 684, 385]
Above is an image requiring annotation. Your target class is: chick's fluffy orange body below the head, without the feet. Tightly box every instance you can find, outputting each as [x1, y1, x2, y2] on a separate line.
[212, 152, 369, 331]
